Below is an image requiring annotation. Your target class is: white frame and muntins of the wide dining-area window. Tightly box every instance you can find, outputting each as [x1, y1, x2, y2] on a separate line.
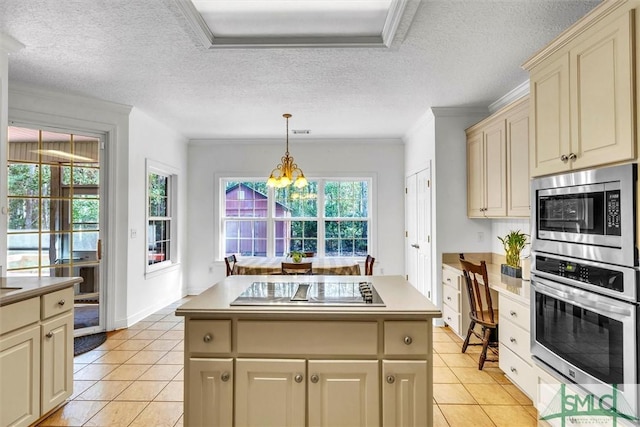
[215, 173, 377, 260]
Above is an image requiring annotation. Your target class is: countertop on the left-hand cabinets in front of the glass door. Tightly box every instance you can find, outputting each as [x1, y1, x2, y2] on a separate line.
[0, 277, 83, 306]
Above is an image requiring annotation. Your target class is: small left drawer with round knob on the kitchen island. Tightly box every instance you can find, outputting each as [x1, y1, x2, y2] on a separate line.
[187, 320, 231, 353]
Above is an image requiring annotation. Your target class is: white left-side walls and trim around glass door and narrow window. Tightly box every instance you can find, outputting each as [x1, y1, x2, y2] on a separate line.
[2, 82, 187, 330]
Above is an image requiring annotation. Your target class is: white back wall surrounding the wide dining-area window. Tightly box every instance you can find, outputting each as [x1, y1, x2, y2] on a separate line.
[187, 138, 404, 294]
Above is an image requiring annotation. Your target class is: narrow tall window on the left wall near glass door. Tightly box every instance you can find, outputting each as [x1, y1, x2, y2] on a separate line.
[147, 161, 177, 271]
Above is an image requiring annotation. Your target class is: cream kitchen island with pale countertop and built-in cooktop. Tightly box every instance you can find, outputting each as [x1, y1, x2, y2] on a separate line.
[176, 276, 441, 426]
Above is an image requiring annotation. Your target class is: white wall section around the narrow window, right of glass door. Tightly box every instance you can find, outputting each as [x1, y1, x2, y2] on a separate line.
[125, 108, 188, 324]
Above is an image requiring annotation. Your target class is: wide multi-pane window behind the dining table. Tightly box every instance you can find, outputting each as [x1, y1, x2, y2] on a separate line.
[220, 178, 371, 256]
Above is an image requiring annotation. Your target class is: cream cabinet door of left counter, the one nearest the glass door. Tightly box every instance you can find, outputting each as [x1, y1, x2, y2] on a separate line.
[41, 311, 73, 414]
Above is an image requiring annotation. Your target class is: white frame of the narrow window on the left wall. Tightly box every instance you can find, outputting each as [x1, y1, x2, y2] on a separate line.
[144, 159, 178, 274]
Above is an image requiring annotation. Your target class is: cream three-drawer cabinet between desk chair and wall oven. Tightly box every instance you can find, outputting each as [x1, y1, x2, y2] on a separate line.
[498, 292, 536, 400]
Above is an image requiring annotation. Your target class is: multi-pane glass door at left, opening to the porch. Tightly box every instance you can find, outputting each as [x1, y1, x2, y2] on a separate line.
[7, 126, 105, 336]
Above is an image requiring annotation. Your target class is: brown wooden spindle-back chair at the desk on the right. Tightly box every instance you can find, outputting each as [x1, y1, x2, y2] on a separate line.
[460, 254, 498, 370]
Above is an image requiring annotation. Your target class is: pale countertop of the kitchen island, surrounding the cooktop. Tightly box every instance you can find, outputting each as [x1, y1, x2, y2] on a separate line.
[176, 275, 442, 320]
